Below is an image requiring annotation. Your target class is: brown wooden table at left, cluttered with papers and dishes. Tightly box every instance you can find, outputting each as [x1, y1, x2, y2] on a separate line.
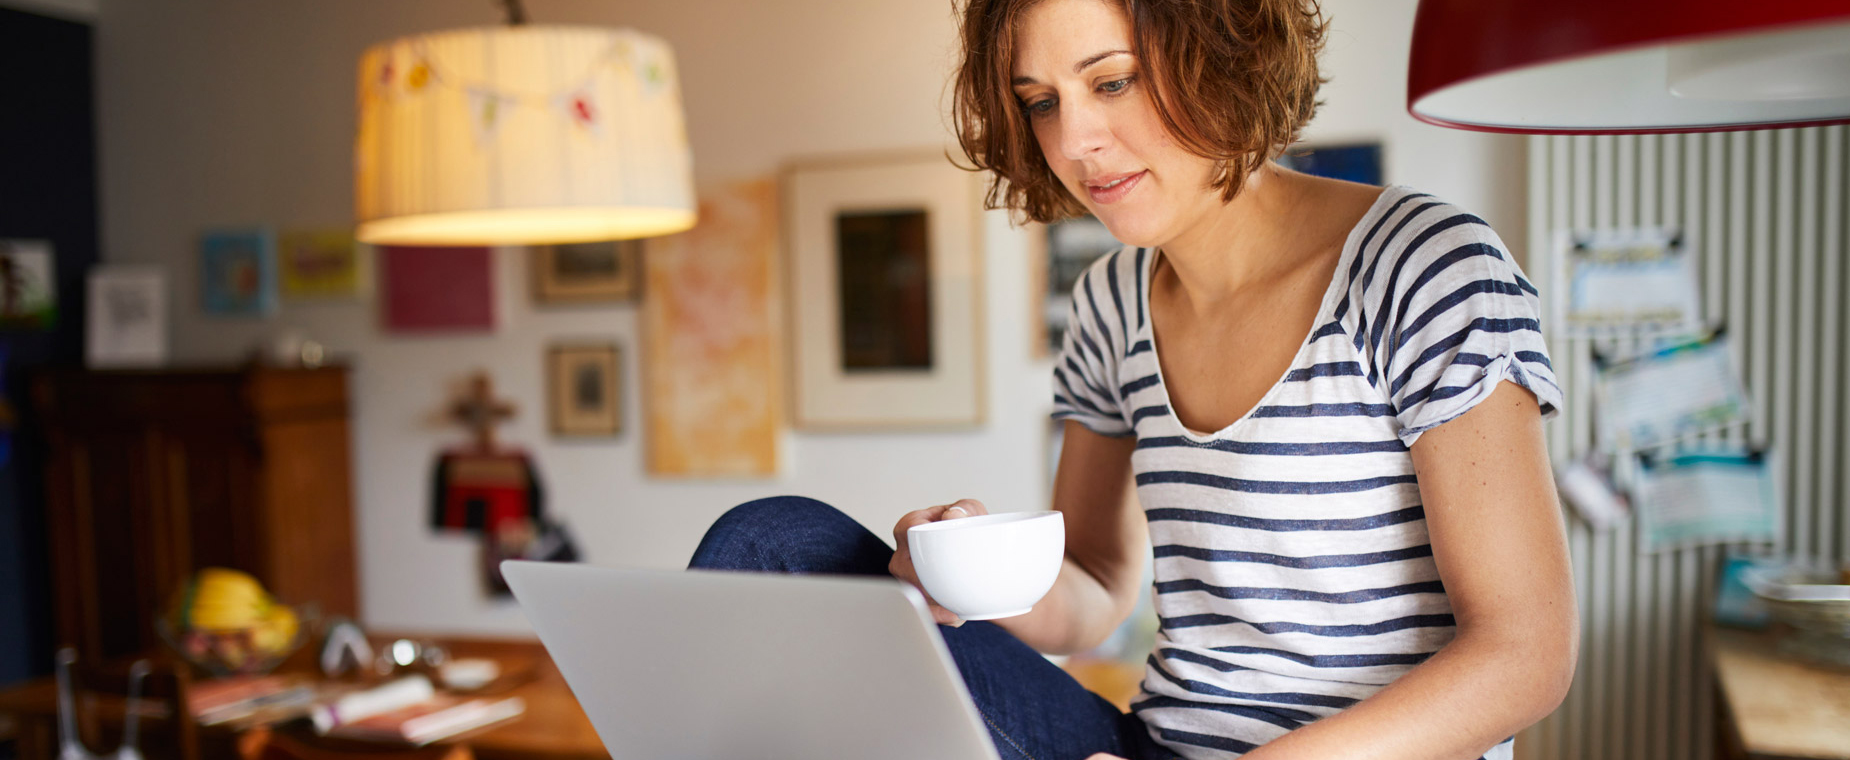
[0, 636, 611, 760]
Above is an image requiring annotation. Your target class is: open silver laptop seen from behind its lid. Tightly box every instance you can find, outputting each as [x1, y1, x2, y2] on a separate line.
[501, 560, 997, 760]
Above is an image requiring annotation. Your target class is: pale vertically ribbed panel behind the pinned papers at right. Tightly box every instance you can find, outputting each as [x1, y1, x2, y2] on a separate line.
[1517, 126, 1850, 760]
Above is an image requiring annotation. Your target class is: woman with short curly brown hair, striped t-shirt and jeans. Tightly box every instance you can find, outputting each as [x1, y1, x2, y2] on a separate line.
[694, 0, 1578, 760]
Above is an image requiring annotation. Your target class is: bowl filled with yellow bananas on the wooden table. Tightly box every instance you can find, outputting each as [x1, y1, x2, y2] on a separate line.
[154, 568, 315, 677]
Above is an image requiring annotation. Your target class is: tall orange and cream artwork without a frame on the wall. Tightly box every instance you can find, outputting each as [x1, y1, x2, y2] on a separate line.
[642, 179, 784, 477]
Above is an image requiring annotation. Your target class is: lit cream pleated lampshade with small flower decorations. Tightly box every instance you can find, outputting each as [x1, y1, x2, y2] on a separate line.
[353, 26, 694, 246]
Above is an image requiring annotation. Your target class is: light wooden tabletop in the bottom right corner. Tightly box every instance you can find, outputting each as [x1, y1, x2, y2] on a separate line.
[1706, 627, 1850, 760]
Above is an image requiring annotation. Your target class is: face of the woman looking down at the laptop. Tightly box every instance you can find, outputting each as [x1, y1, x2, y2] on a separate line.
[1012, 0, 1219, 246]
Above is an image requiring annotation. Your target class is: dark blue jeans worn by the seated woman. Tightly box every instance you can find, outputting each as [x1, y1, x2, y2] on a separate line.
[688, 496, 1175, 760]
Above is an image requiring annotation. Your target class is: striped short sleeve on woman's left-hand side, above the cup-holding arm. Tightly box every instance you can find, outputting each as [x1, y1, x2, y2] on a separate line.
[1053, 251, 1138, 438]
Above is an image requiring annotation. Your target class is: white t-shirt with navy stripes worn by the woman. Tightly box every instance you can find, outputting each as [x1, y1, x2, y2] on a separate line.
[1055, 187, 1561, 760]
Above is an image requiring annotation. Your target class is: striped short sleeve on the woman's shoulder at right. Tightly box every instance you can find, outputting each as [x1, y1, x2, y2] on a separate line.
[1363, 205, 1561, 446]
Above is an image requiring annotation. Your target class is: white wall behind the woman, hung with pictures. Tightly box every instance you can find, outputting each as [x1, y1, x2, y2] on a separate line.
[98, 0, 1524, 631]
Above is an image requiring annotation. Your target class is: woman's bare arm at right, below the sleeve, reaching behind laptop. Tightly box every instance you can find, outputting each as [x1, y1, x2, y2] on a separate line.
[1221, 383, 1580, 760]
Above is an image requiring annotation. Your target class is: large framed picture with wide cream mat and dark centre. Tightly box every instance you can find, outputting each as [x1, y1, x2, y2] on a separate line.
[783, 152, 984, 429]
